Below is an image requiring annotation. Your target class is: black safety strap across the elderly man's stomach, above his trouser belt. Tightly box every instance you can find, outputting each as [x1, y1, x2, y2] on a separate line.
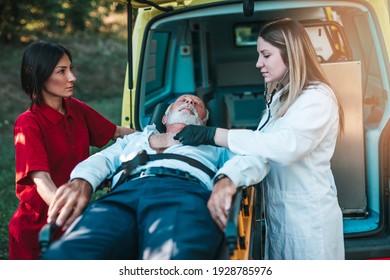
[112, 150, 215, 186]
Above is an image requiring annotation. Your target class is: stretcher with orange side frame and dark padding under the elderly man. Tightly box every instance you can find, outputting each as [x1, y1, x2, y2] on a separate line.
[39, 100, 262, 260]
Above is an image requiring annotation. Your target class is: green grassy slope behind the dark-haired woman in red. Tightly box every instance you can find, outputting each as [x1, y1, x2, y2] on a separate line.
[0, 34, 127, 260]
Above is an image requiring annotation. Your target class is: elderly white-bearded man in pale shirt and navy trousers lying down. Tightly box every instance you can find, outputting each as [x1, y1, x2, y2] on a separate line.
[43, 95, 268, 260]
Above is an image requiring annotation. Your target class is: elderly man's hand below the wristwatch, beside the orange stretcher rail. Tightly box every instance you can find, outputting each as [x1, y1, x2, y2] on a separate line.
[207, 177, 237, 231]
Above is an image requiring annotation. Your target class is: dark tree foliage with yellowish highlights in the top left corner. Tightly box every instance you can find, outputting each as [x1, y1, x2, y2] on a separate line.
[0, 0, 123, 42]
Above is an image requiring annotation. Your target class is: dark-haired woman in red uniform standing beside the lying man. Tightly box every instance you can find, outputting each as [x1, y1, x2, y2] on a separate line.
[9, 41, 133, 259]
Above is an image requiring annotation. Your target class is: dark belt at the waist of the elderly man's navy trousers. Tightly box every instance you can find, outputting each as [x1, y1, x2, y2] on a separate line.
[124, 166, 203, 184]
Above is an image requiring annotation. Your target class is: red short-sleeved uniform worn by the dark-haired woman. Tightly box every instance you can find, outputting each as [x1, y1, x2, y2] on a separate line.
[9, 98, 116, 258]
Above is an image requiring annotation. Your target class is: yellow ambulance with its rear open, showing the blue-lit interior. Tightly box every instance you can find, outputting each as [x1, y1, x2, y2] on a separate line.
[116, 0, 390, 259]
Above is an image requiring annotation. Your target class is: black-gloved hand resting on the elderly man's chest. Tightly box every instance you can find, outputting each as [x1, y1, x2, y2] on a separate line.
[173, 124, 217, 146]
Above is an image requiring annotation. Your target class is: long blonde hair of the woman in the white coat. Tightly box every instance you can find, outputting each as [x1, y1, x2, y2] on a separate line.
[259, 18, 344, 132]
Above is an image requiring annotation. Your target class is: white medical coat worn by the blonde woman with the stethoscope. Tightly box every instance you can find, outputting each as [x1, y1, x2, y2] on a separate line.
[228, 84, 344, 260]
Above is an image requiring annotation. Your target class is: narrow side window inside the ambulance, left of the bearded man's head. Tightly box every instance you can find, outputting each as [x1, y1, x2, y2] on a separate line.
[145, 32, 170, 95]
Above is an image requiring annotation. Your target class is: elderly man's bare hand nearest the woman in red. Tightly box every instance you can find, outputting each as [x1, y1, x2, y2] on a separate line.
[47, 179, 92, 231]
